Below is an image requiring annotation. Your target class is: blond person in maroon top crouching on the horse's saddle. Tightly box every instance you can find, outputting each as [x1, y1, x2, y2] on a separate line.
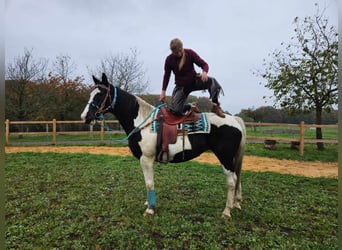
[159, 38, 225, 118]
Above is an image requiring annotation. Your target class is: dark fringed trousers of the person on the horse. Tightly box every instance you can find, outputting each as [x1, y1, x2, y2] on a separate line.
[171, 77, 222, 115]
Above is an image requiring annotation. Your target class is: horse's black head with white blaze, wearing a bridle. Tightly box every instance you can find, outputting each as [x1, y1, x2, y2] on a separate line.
[81, 73, 116, 124]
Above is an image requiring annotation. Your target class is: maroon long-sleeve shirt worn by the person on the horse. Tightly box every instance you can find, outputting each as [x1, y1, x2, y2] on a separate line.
[162, 49, 209, 90]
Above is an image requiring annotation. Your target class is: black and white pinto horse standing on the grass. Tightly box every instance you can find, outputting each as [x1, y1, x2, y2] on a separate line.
[81, 73, 246, 219]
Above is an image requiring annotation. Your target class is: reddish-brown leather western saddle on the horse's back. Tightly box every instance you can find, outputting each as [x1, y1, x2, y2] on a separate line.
[156, 106, 201, 163]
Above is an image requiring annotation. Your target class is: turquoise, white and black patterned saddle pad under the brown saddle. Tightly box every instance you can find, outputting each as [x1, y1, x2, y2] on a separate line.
[151, 113, 210, 134]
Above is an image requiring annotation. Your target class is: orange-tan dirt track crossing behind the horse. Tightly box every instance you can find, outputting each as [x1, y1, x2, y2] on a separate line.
[5, 146, 338, 178]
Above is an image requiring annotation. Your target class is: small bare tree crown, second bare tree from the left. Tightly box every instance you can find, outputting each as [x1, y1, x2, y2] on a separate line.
[52, 55, 77, 83]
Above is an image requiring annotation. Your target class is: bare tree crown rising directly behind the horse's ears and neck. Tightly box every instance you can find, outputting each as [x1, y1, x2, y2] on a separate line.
[92, 49, 148, 94]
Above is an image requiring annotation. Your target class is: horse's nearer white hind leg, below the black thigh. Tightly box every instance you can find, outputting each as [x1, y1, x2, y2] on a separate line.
[222, 167, 237, 219]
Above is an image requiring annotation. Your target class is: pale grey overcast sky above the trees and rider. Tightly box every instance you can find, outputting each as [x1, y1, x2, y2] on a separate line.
[5, 0, 338, 114]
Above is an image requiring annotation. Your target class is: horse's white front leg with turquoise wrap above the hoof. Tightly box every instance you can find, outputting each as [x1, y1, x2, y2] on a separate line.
[140, 155, 156, 216]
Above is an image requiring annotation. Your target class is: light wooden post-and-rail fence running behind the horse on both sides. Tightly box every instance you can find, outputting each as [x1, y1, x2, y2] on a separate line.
[5, 119, 338, 155]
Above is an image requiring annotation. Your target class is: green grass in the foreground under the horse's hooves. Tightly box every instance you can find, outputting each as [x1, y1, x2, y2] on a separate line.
[5, 153, 338, 249]
